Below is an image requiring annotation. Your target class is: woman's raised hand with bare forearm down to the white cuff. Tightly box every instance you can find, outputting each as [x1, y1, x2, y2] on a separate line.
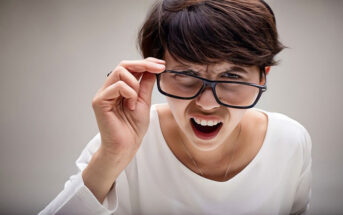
[82, 58, 165, 203]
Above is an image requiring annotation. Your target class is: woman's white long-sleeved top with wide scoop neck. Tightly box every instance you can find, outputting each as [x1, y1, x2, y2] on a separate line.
[39, 105, 312, 215]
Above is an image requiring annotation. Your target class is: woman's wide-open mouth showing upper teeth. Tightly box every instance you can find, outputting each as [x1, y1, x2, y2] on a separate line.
[190, 118, 223, 140]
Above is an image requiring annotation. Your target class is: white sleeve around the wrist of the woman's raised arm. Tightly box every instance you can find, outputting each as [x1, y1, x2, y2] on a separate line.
[39, 133, 118, 215]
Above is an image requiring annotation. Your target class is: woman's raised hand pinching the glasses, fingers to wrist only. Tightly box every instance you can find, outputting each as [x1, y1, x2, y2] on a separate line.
[92, 57, 165, 159]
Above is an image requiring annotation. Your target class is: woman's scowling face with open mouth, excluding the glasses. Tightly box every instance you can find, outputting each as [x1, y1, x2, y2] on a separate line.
[165, 52, 264, 151]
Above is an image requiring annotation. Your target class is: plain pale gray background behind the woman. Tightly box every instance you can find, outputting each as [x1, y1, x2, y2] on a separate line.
[0, 0, 343, 214]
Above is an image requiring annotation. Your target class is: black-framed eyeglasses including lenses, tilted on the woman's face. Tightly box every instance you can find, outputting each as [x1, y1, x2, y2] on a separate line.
[156, 70, 267, 109]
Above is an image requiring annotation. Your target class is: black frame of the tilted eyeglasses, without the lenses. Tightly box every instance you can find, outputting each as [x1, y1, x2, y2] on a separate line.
[156, 70, 267, 109]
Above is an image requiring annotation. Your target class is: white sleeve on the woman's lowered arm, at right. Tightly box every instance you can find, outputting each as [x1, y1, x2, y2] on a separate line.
[291, 128, 312, 215]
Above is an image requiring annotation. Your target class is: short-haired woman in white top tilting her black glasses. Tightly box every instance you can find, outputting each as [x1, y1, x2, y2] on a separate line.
[41, 0, 311, 214]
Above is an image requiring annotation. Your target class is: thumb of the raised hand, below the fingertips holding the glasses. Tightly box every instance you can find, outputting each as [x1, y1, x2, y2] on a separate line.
[138, 72, 156, 106]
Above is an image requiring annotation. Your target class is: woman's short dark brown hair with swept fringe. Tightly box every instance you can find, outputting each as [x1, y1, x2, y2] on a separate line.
[138, 0, 285, 68]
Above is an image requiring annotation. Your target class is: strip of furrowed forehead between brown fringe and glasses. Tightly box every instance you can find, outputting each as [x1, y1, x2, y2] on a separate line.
[165, 51, 258, 74]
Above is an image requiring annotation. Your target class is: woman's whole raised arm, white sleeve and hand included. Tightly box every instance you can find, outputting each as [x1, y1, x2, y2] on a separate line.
[40, 57, 165, 214]
